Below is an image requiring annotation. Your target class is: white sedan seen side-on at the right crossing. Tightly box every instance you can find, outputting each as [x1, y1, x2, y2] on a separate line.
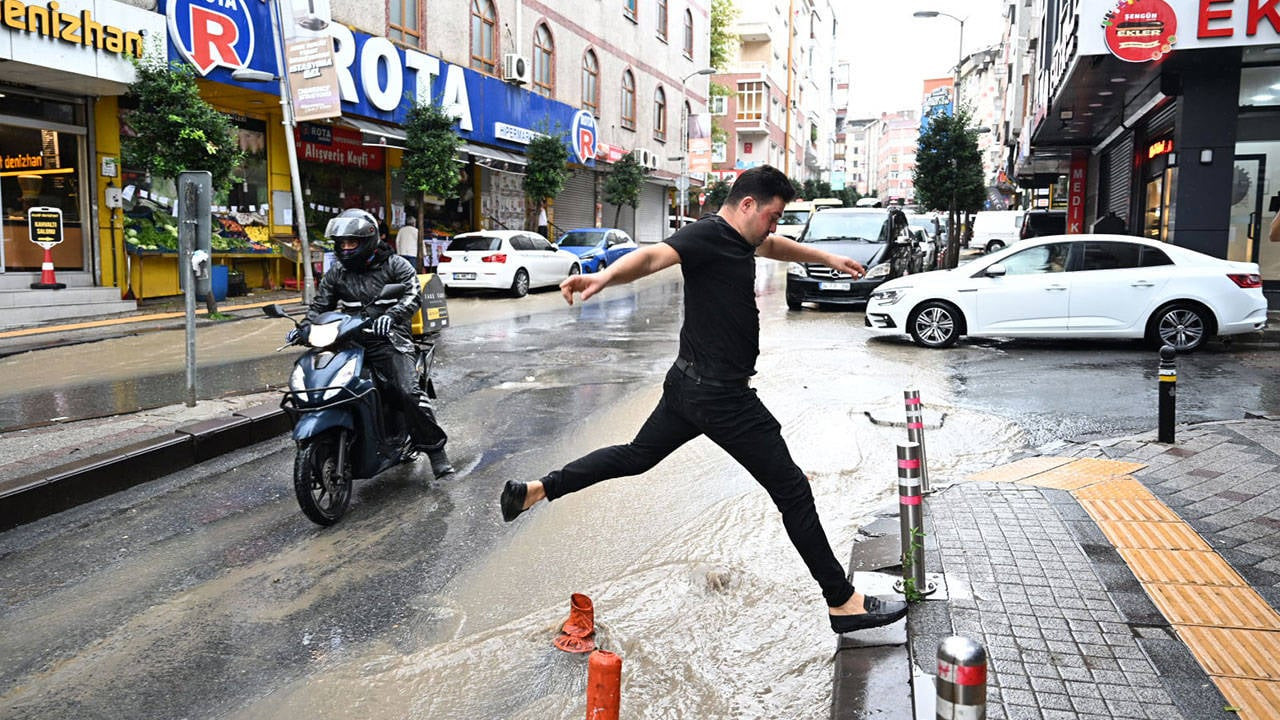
[867, 234, 1267, 352]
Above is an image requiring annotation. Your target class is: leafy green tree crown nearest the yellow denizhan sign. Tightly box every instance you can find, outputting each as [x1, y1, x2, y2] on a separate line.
[122, 55, 244, 192]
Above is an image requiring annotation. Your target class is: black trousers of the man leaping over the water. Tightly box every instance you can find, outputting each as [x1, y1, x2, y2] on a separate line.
[543, 368, 854, 607]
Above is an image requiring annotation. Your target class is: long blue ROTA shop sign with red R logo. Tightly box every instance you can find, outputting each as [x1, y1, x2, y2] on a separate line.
[161, 0, 595, 165]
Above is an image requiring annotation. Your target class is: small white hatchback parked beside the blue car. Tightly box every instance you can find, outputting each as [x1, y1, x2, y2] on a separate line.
[435, 231, 582, 297]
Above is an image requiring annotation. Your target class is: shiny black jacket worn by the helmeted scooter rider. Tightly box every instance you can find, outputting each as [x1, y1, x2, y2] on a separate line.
[307, 246, 422, 352]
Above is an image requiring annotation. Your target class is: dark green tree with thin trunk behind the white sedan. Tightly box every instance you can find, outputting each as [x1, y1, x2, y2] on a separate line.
[915, 109, 987, 268]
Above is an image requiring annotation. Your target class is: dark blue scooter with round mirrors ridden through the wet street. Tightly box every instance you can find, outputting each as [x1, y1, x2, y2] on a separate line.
[262, 284, 435, 525]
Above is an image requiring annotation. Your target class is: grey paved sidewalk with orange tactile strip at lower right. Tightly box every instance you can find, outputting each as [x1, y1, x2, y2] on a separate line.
[832, 419, 1280, 720]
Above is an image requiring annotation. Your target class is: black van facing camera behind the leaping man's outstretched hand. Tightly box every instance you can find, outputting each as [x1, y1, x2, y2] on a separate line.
[787, 208, 922, 310]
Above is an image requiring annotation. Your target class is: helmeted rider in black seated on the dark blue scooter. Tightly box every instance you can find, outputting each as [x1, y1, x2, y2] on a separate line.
[298, 209, 453, 478]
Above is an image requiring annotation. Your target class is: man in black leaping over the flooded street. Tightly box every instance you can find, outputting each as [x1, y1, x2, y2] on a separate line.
[499, 165, 906, 633]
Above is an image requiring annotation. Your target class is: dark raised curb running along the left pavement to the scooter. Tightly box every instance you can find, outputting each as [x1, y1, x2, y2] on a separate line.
[0, 404, 289, 532]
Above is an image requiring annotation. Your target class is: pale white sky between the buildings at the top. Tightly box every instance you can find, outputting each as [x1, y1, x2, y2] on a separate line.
[833, 0, 1005, 118]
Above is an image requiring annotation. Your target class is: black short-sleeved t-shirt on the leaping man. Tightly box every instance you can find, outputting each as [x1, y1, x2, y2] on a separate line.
[664, 215, 760, 380]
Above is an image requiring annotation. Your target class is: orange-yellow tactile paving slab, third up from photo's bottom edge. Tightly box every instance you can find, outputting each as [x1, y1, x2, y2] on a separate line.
[1143, 583, 1280, 627]
